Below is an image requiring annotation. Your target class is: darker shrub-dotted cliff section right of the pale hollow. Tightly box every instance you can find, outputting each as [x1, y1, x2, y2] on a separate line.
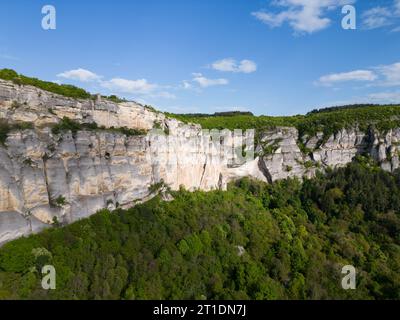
[260, 128, 400, 181]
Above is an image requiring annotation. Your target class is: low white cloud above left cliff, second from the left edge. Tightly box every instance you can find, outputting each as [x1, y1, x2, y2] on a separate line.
[101, 78, 157, 94]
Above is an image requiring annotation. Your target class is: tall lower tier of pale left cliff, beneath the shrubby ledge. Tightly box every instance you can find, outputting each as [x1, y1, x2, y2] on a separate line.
[0, 124, 238, 242]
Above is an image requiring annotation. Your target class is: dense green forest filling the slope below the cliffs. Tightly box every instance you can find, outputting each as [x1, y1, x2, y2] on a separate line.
[0, 157, 400, 300]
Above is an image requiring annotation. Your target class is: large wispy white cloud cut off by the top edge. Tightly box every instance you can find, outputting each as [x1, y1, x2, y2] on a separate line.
[252, 0, 355, 33]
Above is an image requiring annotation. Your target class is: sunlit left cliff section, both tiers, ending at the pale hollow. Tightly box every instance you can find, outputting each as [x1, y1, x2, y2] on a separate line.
[0, 80, 260, 244]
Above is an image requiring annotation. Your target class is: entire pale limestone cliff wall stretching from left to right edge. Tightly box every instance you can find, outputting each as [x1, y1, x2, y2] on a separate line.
[0, 80, 400, 244]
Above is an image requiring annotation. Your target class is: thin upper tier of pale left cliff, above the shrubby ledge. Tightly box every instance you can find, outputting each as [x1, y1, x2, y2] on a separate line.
[0, 80, 165, 129]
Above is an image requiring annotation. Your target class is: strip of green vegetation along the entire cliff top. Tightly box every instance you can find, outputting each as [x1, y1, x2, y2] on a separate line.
[0, 69, 400, 141]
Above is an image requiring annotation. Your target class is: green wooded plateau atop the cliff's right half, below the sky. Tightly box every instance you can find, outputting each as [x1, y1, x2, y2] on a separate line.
[170, 105, 400, 137]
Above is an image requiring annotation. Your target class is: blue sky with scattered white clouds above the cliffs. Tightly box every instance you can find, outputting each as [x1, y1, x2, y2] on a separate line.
[0, 0, 400, 115]
